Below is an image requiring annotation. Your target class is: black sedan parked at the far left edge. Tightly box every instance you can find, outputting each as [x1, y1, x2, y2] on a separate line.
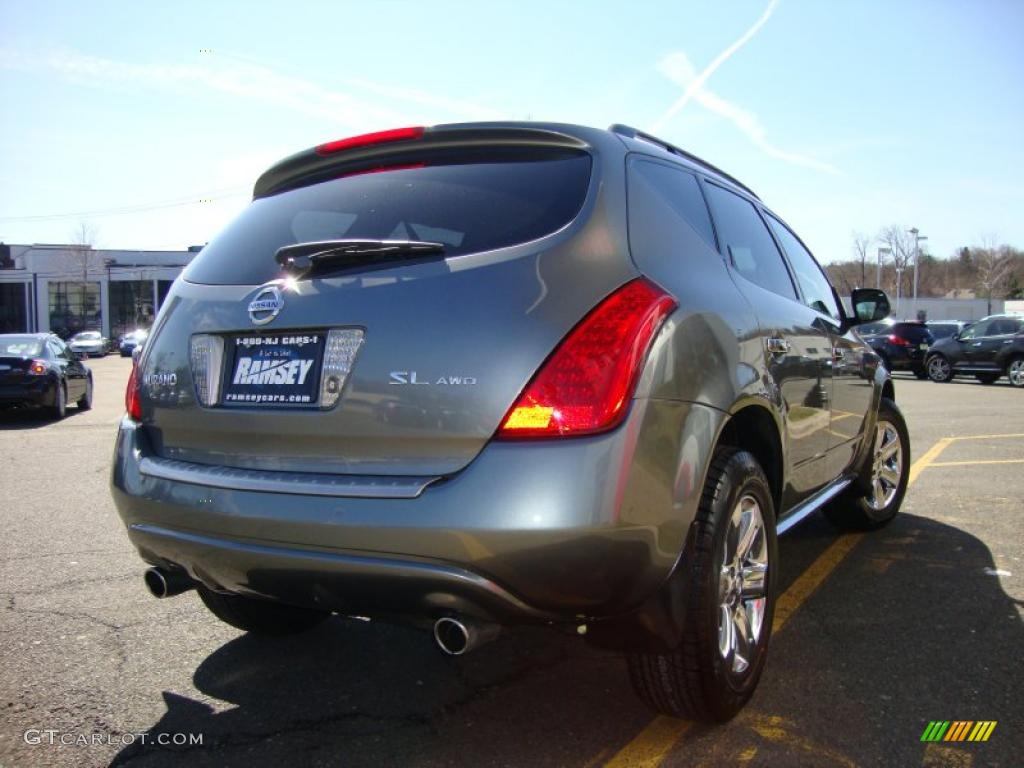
[0, 334, 92, 419]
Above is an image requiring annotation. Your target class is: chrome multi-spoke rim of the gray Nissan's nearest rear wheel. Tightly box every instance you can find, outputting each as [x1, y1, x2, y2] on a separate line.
[718, 495, 768, 675]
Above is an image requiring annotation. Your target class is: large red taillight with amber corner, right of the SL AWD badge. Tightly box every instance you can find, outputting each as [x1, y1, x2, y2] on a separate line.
[498, 278, 676, 437]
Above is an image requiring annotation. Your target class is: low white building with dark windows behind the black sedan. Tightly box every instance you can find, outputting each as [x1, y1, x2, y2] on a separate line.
[0, 244, 202, 339]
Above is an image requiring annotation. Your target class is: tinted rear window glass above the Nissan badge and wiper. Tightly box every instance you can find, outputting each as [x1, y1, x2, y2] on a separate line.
[184, 151, 591, 285]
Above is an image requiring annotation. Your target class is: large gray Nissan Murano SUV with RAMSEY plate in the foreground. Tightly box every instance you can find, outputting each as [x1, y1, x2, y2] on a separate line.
[112, 123, 909, 720]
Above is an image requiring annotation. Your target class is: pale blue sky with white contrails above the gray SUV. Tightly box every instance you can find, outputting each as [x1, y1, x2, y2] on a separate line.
[0, 0, 1024, 263]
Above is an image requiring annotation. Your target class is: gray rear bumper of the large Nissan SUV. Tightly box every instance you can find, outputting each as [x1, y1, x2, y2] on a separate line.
[112, 400, 721, 624]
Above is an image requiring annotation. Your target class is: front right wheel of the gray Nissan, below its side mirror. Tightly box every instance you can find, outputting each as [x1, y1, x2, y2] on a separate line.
[824, 397, 910, 530]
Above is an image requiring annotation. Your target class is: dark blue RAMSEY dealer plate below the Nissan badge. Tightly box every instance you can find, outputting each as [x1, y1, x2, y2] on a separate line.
[219, 330, 327, 411]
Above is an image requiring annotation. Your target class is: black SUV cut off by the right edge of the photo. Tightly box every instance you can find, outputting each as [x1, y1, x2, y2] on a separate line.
[926, 314, 1024, 387]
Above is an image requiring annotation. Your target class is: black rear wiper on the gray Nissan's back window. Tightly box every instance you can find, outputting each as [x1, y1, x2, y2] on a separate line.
[274, 240, 444, 278]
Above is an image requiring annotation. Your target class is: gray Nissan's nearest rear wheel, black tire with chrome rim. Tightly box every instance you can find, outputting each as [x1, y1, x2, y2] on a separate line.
[627, 449, 776, 722]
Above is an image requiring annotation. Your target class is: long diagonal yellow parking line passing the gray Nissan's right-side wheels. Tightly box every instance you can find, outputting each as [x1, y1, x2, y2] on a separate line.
[605, 437, 953, 768]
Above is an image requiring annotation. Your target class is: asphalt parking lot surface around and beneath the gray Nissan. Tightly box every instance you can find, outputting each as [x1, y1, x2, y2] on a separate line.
[0, 356, 1024, 768]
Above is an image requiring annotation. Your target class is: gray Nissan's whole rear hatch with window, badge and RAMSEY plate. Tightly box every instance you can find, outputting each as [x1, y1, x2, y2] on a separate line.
[140, 126, 636, 476]
